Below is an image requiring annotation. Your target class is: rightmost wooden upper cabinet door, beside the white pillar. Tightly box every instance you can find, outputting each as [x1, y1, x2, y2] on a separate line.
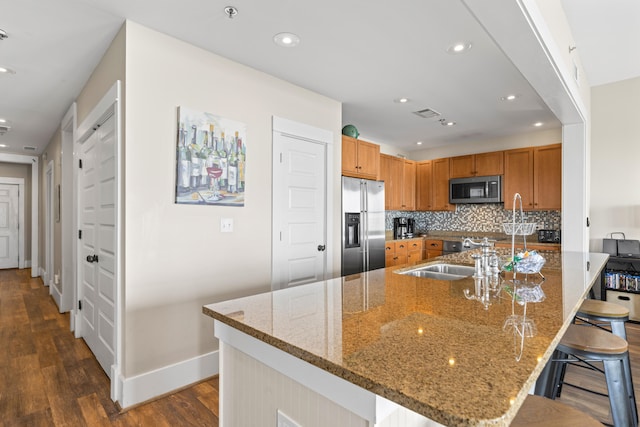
[533, 144, 562, 210]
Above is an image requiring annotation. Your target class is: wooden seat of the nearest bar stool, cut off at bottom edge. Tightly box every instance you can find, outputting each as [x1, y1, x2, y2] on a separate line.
[511, 394, 604, 427]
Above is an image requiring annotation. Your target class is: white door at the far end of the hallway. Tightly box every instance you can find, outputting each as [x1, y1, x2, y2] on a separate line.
[0, 184, 19, 268]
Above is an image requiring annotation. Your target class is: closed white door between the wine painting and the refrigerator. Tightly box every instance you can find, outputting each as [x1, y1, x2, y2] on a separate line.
[272, 132, 327, 288]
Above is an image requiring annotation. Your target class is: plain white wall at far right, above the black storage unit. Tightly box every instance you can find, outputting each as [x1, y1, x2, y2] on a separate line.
[589, 77, 640, 251]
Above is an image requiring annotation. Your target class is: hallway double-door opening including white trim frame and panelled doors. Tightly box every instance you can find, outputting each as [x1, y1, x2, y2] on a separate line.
[74, 81, 122, 401]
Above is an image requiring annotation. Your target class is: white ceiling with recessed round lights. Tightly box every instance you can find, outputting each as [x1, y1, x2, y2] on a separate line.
[0, 0, 640, 154]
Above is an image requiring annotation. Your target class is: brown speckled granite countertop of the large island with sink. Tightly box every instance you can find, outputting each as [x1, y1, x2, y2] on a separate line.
[203, 251, 607, 426]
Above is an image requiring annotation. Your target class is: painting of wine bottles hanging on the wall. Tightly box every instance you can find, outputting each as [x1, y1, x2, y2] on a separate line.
[175, 107, 247, 206]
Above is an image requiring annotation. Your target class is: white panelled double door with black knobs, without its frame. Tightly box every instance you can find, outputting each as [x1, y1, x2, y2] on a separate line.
[78, 115, 116, 376]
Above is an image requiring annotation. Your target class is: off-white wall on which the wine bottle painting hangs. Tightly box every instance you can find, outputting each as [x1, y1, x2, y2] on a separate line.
[123, 22, 342, 377]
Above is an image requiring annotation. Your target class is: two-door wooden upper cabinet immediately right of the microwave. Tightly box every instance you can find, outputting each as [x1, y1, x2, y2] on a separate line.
[503, 144, 562, 210]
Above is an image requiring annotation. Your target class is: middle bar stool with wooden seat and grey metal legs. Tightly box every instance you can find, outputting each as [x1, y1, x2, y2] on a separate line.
[545, 324, 638, 427]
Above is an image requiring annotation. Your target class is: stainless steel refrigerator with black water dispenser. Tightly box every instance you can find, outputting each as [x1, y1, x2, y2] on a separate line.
[342, 176, 385, 276]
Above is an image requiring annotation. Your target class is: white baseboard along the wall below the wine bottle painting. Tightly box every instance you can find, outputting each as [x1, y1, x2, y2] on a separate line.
[117, 350, 220, 410]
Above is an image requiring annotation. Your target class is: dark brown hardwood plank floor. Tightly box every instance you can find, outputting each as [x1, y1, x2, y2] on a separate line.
[0, 269, 640, 427]
